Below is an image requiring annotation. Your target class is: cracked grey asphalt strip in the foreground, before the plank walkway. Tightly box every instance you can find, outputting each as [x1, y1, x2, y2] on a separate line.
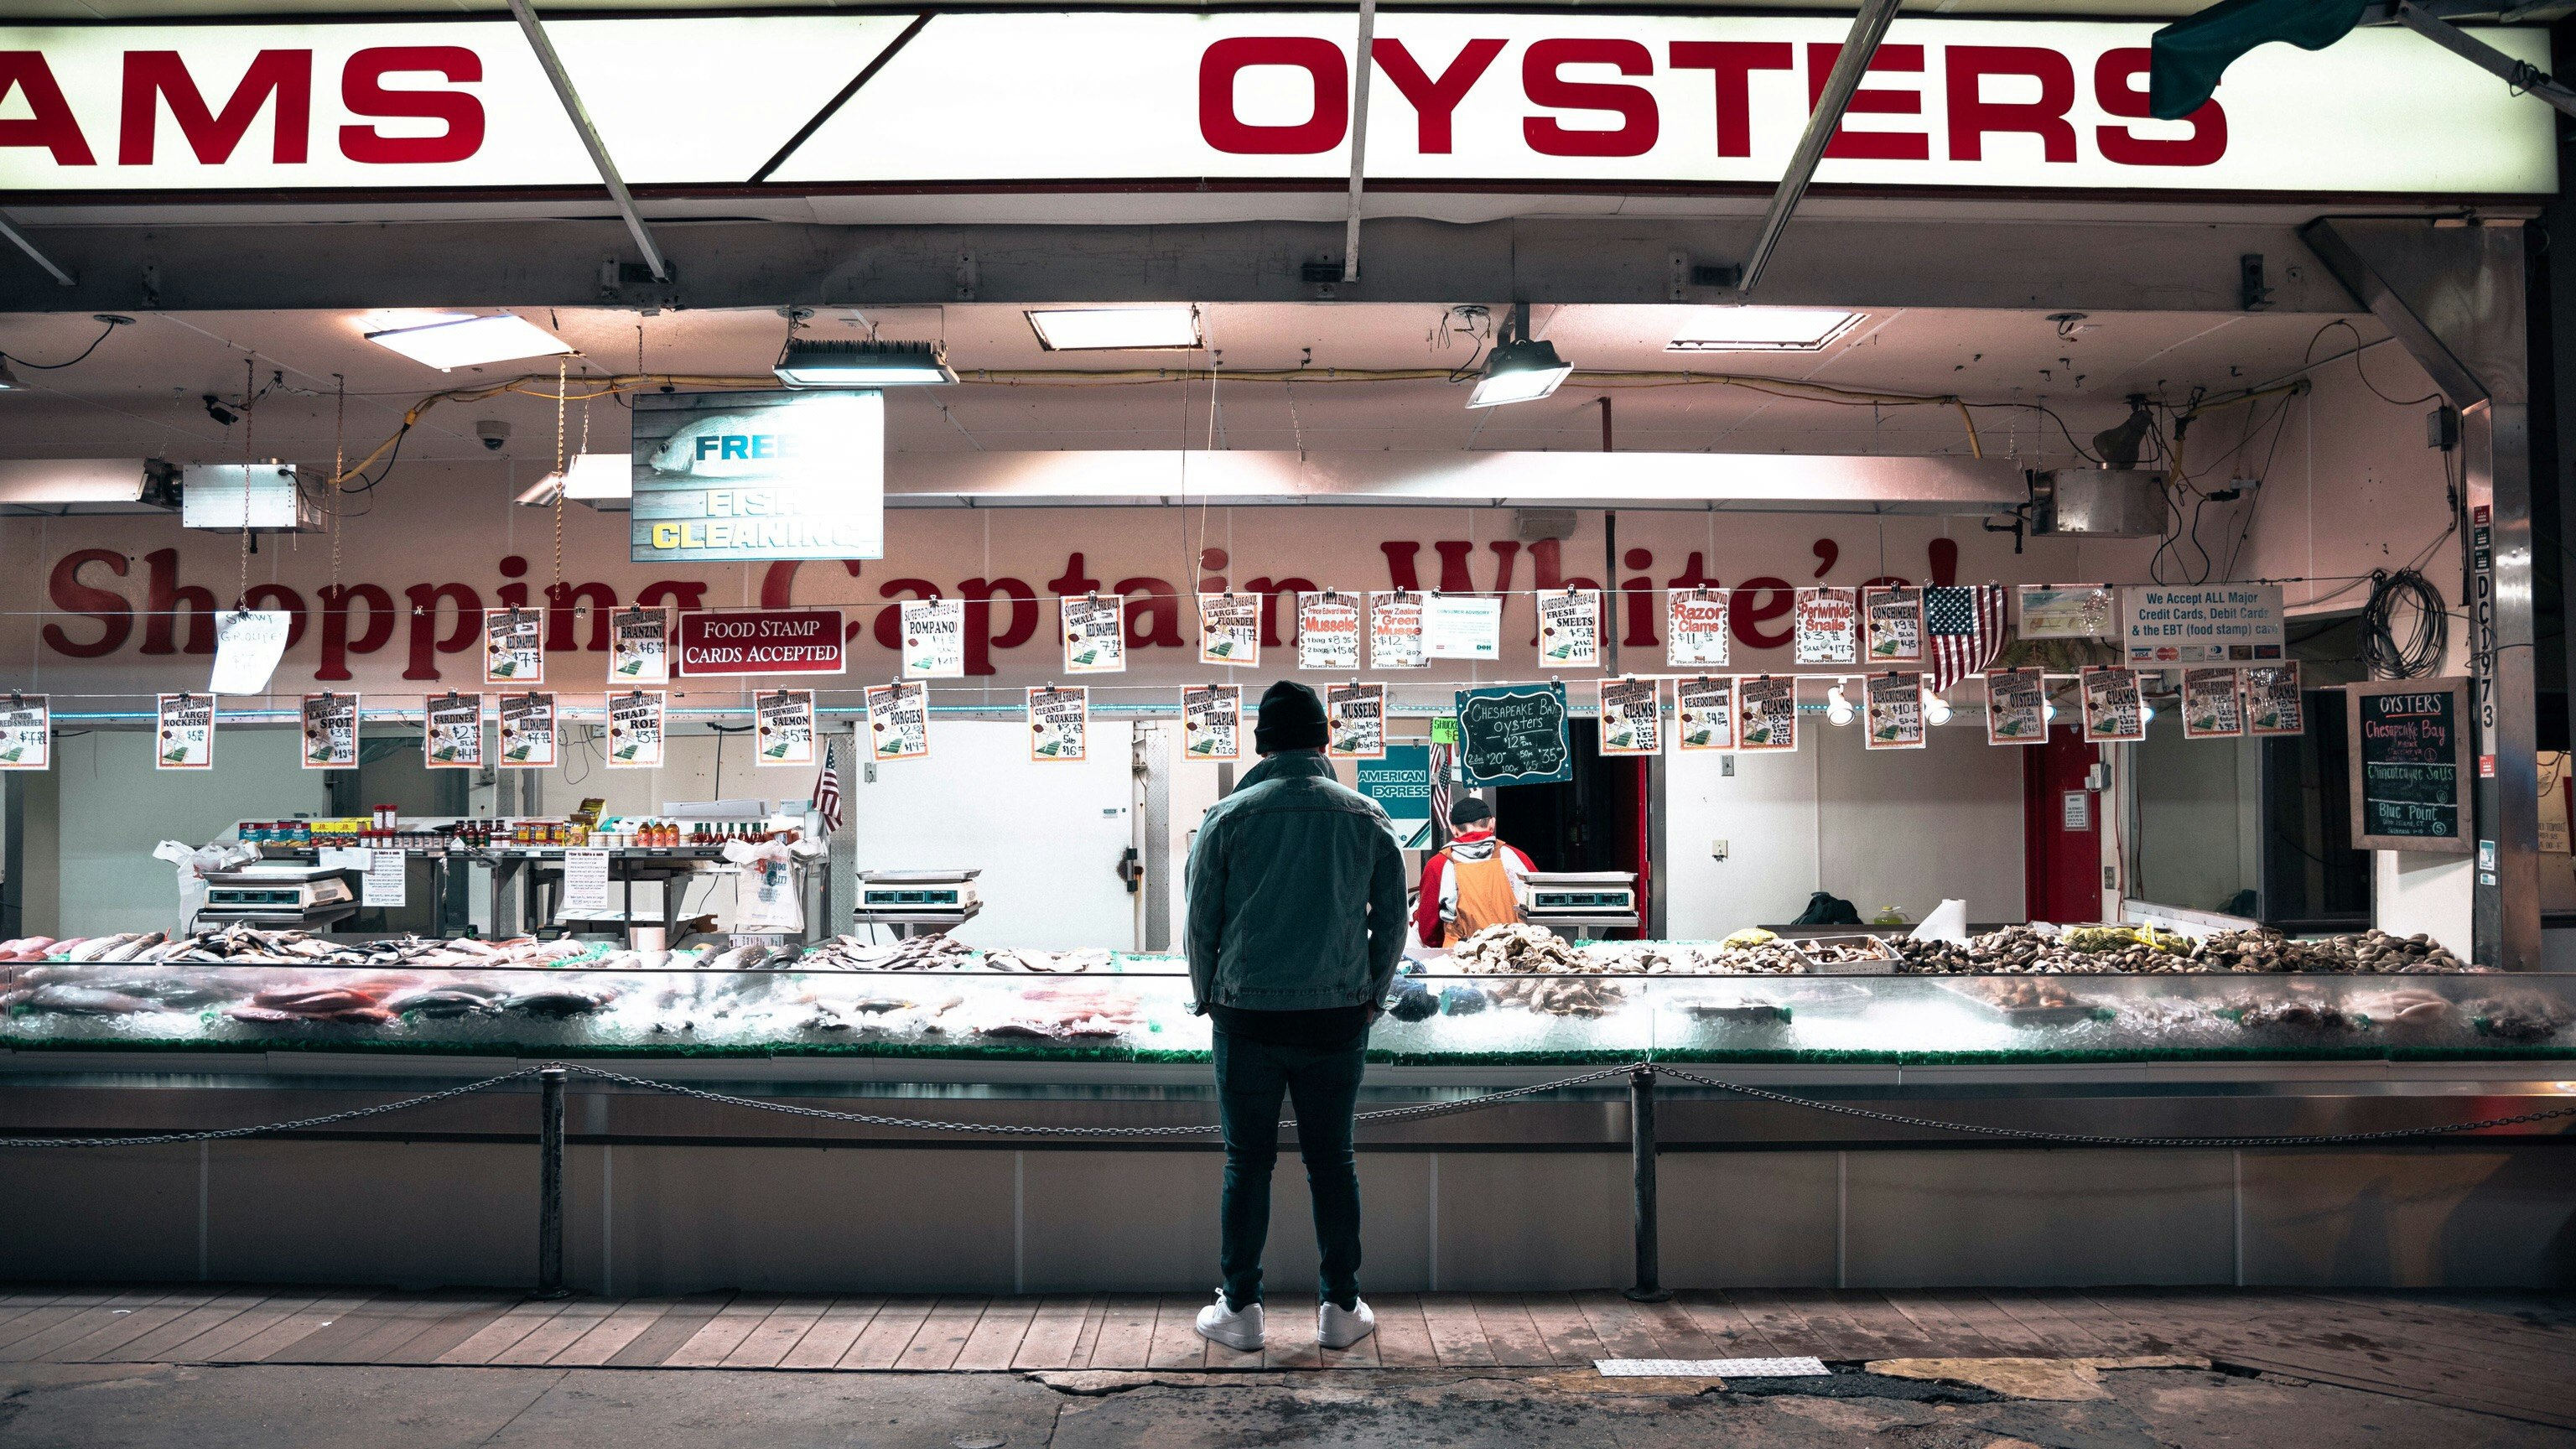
[0, 1364, 2576, 1449]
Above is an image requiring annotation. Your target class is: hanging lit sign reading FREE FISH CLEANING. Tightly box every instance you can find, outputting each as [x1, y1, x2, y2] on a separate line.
[631, 389, 886, 564]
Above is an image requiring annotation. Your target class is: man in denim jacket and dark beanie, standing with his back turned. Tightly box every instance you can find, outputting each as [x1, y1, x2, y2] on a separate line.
[1187, 681, 1404, 1351]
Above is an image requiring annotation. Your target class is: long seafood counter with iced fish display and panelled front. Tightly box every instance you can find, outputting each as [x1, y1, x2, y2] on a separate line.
[0, 943, 2576, 1291]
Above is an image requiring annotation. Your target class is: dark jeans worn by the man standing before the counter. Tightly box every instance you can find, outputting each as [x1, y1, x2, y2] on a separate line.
[1216, 1031, 1368, 1310]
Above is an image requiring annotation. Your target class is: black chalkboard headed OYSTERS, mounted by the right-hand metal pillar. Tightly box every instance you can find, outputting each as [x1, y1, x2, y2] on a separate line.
[2345, 678, 2473, 856]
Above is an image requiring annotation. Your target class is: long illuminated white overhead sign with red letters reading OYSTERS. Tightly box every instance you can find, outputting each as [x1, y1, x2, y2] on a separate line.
[0, 10, 2558, 199]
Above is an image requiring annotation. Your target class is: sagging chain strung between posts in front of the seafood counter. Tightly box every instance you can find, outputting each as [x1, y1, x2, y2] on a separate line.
[0, 1046, 2576, 1147]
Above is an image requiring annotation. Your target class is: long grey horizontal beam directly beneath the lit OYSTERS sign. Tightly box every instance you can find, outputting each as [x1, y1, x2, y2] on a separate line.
[0, 214, 2357, 317]
